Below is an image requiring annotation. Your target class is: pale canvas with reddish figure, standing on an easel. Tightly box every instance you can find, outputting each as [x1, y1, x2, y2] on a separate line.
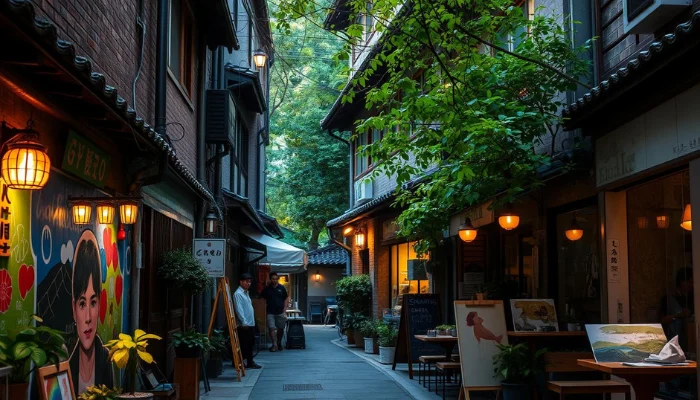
[454, 301, 508, 388]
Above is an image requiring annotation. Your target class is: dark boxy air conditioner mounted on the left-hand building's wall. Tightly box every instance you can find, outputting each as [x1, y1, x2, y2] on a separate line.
[206, 89, 236, 144]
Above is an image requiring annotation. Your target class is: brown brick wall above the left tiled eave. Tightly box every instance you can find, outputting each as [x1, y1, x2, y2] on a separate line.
[30, 0, 208, 177]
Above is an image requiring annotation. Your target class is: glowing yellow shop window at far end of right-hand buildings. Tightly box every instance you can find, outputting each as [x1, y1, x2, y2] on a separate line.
[391, 242, 432, 307]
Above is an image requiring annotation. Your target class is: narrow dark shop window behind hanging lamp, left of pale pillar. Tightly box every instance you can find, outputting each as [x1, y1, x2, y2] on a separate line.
[556, 206, 601, 323]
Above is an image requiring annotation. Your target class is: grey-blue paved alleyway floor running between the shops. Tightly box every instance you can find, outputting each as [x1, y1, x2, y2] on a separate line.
[202, 325, 414, 400]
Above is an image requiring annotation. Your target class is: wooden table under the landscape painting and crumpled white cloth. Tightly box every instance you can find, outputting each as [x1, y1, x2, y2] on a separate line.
[577, 360, 697, 400]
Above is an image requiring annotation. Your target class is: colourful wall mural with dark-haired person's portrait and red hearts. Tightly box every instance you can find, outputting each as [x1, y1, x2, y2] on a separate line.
[0, 174, 131, 393]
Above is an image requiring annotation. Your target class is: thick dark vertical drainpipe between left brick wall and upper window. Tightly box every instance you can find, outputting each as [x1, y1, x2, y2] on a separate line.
[155, 0, 170, 136]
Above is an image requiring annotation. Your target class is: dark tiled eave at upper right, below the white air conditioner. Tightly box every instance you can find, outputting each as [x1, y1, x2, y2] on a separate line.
[562, 10, 700, 122]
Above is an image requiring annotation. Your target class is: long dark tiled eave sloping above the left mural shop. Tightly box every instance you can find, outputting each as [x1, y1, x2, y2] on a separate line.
[0, 0, 223, 218]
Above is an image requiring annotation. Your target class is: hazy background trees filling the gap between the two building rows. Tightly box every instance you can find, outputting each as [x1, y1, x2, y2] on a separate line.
[267, 0, 349, 249]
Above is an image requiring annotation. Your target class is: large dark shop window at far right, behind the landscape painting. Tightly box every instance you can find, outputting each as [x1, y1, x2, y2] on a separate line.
[627, 171, 697, 399]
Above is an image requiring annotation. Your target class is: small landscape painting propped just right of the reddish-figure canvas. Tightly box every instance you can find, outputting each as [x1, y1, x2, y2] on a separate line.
[510, 299, 559, 332]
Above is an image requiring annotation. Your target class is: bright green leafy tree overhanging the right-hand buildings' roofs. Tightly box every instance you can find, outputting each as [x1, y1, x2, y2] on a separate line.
[278, 0, 588, 253]
